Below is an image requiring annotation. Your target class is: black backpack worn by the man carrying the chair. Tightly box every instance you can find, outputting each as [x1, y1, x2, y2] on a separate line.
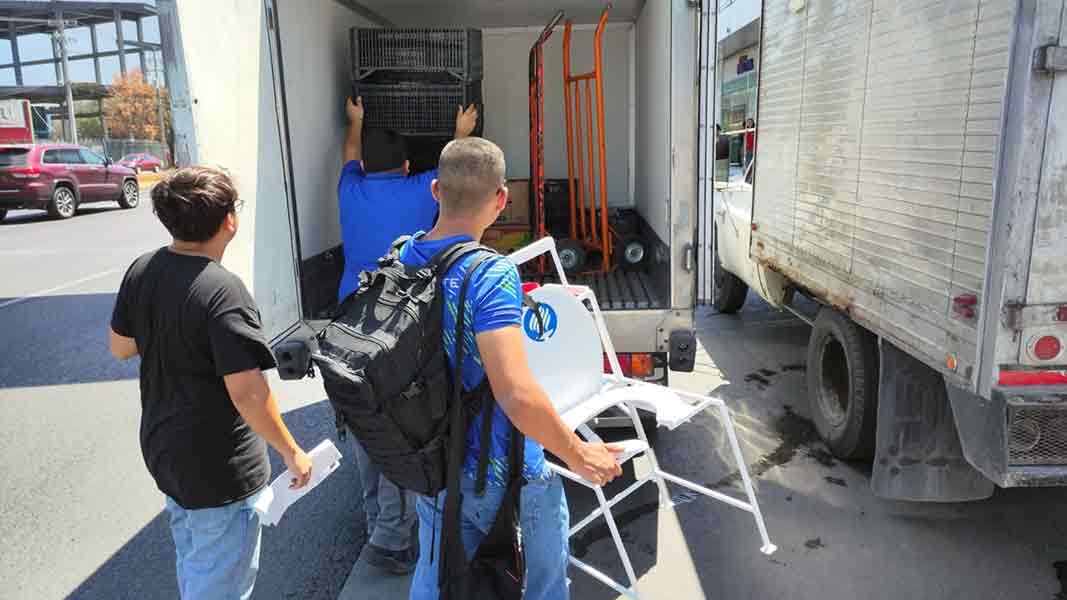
[312, 237, 493, 495]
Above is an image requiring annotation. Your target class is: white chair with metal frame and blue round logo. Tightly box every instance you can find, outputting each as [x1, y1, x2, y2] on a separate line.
[509, 238, 777, 599]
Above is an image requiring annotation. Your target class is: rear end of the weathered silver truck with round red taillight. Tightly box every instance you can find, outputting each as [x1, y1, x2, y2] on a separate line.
[977, 5, 1067, 392]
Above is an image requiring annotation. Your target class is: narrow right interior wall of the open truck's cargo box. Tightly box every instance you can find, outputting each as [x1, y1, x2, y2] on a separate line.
[635, 1, 671, 243]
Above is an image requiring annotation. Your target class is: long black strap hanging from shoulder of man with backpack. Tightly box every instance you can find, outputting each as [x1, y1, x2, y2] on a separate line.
[433, 249, 490, 588]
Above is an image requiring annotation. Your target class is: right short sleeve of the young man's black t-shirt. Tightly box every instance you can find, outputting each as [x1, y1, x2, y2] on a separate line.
[208, 278, 276, 377]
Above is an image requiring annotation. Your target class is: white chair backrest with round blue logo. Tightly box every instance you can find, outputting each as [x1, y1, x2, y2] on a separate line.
[523, 285, 604, 413]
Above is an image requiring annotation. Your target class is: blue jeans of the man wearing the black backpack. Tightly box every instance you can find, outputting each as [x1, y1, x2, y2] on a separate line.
[411, 476, 571, 600]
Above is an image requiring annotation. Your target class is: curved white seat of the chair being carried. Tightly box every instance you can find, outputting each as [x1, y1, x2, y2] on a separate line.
[560, 377, 707, 430]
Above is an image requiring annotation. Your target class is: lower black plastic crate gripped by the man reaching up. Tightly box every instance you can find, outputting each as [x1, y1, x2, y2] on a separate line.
[352, 80, 485, 137]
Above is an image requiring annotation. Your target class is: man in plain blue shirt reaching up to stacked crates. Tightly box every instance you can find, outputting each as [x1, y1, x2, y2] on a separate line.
[337, 98, 478, 574]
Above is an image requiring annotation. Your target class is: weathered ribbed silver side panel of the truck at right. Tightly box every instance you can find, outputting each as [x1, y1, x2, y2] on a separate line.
[752, 0, 1017, 380]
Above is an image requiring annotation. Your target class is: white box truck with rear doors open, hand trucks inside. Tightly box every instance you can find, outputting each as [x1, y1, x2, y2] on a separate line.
[158, 0, 714, 414]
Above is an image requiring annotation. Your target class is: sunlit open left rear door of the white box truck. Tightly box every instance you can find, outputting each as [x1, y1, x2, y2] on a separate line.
[160, 2, 300, 338]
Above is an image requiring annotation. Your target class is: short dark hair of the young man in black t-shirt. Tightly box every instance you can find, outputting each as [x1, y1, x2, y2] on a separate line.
[152, 167, 238, 241]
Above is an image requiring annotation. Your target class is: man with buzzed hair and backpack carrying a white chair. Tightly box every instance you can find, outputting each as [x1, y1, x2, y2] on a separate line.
[400, 138, 622, 600]
